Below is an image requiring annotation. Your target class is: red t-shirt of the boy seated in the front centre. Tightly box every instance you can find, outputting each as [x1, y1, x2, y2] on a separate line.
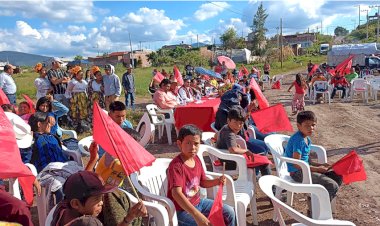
[166, 155, 206, 211]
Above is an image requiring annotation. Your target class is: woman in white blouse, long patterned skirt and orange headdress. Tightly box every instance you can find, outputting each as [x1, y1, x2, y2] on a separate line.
[65, 66, 88, 130]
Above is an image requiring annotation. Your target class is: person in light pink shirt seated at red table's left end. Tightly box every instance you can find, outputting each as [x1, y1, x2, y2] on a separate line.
[153, 79, 178, 109]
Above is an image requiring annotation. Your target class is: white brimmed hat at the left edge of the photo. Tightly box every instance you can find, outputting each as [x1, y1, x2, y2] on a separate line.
[5, 112, 33, 148]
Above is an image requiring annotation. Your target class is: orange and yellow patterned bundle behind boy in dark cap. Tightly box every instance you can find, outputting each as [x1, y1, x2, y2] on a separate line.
[95, 153, 126, 186]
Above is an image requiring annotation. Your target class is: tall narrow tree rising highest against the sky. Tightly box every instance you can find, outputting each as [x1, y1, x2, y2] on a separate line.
[251, 2, 268, 53]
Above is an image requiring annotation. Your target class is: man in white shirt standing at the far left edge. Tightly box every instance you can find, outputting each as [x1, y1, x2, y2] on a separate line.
[0, 64, 17, 105]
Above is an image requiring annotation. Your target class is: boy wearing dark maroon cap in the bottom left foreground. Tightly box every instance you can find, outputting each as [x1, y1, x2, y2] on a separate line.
[51, 171, 147, 226]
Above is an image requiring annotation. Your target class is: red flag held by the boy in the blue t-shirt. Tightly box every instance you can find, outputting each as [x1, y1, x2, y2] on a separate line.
[332, 150, 367, 184]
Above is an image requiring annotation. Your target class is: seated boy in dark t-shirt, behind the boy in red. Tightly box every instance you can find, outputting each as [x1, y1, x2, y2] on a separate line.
[215, 106, 271, 175]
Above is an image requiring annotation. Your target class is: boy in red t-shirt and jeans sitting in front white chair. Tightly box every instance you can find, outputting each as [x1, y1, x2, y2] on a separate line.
[167, 125, 235, 226]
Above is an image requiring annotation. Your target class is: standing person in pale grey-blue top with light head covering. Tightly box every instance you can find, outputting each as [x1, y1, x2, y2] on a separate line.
[103, 64, 121, 111]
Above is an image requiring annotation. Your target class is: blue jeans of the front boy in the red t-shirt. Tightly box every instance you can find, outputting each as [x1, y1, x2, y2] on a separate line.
[177, 199, 236, 226]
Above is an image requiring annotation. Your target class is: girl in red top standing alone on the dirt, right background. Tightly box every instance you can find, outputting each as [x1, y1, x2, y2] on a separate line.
[288, 73, 307, 115]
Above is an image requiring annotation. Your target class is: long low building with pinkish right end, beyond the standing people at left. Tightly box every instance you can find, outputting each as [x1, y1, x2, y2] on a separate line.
[88, 50, 152, 67]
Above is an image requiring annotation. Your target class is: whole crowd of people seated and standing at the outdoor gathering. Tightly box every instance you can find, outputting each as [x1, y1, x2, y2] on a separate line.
[0, 58, 347, 225]
